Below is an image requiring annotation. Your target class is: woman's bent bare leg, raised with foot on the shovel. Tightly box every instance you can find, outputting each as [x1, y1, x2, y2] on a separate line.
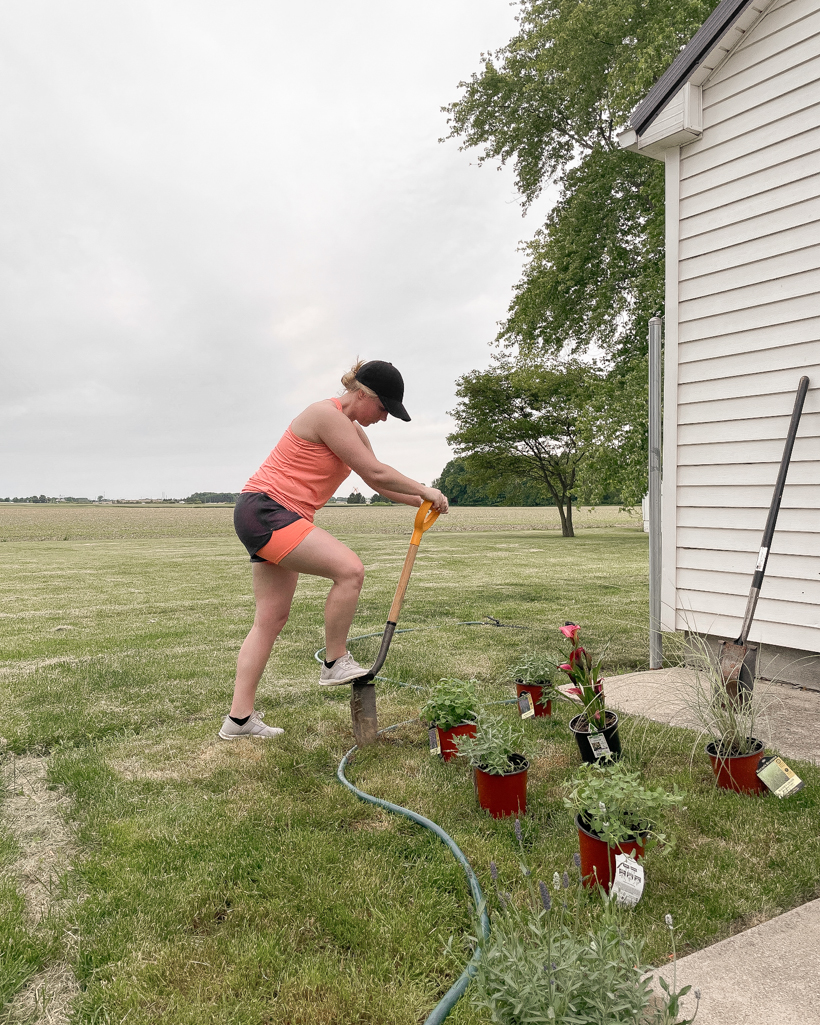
[279, 527, 365, 662]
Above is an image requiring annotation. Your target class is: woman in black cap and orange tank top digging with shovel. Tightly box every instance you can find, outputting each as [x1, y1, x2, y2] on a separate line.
[219, 360, 448, 740]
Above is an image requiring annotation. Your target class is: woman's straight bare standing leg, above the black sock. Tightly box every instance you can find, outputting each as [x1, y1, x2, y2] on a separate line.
[231, 557, 299, 719]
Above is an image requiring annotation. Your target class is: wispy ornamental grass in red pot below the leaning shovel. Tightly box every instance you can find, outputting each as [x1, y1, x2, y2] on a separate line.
[682, 634, 766, 794]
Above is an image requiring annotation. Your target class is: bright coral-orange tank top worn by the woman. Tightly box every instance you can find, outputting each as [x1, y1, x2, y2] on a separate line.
[242, 399, 351, 523]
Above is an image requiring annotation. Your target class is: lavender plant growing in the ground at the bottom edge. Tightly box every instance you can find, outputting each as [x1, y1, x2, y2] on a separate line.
[470, 855, 693, 1025]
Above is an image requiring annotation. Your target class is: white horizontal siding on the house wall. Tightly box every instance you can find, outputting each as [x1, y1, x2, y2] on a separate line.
[664, 0, 820, 652]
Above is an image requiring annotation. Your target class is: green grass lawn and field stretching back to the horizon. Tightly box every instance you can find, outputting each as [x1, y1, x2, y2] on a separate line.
[0, 505, 820, 1025]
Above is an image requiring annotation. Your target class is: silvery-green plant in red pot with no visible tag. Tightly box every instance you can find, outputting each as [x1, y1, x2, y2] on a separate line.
[456, 712, 529, 819]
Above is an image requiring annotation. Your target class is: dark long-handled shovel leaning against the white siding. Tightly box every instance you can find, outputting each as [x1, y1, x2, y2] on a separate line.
[718, 377, 809, 700]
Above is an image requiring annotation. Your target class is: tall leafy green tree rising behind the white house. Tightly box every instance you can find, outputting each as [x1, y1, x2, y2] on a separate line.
[447, 0, 718, 498]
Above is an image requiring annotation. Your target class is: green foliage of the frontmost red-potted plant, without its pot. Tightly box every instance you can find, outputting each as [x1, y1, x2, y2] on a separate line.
[564, 762, 684, 847]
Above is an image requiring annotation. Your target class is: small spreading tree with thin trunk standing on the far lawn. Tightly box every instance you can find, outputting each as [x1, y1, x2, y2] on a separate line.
[448, 358, 605, 537]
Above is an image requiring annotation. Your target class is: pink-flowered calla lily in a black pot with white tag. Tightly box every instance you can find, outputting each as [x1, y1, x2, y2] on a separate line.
[559, 623, 621, 763]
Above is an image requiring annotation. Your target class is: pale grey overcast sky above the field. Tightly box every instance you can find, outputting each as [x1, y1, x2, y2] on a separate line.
[0, 0, 547, 498]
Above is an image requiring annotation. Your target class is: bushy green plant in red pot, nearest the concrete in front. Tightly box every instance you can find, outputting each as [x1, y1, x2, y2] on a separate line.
[564, 761, 684, 893]
